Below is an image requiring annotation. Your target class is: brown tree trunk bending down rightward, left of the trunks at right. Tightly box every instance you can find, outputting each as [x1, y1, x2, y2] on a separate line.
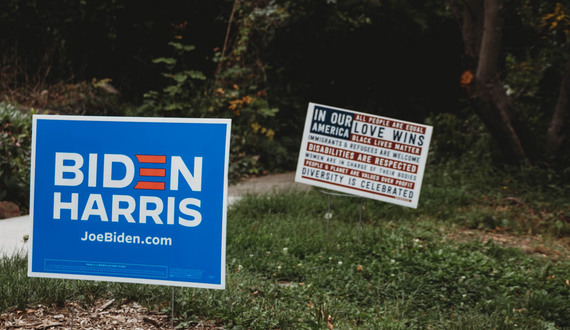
[452, 0, 533, 163]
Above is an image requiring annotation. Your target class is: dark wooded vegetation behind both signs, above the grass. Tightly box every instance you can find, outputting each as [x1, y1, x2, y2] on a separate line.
[0, 0, 570, 208]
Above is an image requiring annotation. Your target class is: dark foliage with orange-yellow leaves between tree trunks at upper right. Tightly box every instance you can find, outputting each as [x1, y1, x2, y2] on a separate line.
[490, 0, 570, 162]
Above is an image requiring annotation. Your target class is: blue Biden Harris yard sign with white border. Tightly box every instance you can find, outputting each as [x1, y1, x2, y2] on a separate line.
[28, 115, 231, 289]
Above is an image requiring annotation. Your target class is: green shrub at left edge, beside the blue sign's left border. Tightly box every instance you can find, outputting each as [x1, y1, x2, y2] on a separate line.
[0, 102, 32, 210]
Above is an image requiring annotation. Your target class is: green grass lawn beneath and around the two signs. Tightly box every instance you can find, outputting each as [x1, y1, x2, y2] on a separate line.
[0, 162, 570, 329]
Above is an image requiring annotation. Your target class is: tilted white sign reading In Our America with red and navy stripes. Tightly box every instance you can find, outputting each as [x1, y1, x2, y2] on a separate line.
[295, 103, 432, 208]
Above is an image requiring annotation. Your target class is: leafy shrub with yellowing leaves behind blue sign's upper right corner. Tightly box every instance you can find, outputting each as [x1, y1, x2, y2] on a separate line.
[137, 17, 287, 180]
